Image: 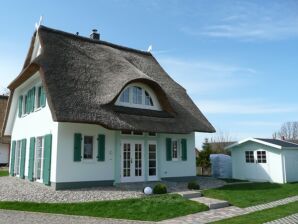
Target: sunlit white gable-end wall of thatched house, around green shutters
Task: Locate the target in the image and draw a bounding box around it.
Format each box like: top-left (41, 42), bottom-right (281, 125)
top-left (9, 72), bottom-right (58, 182)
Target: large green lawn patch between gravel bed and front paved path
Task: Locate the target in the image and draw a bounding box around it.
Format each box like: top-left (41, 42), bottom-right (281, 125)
top-left (0, 194), bottom-right (208, 221)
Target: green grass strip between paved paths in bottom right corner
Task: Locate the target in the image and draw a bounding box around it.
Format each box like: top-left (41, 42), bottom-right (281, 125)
top-left (213, 202), bottom-right (298, 224)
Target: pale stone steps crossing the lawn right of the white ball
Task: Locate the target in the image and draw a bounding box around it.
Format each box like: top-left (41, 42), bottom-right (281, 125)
top-left (178, 191), bottom-right (230, 209)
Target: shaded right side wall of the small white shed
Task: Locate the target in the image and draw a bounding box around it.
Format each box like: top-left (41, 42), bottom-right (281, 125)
top-left (283, 149), bottom-right (298, 182)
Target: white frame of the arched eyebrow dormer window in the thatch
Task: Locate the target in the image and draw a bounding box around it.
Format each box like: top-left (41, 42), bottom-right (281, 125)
top-left (115, 83), bottom-right (161, 111)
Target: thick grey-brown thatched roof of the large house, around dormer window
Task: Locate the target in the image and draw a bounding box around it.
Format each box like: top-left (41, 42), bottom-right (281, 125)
top-left (3, 26), bottom-right (215, 133)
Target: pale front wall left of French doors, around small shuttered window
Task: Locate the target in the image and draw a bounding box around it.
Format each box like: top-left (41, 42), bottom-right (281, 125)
top-left (55, 123), bottom-right (115, 182)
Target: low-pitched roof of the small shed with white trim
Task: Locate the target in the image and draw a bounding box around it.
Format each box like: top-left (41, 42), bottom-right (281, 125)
top-left (225, 138), bottom-right (298, 149)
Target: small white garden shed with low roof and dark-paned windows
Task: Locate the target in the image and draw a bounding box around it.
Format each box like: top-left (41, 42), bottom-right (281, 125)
top-left (225, 138), bottom-right (298, 183)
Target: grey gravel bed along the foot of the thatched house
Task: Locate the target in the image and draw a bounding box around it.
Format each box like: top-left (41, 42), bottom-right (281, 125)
top-left (0, 177), bottom-right (225, 203)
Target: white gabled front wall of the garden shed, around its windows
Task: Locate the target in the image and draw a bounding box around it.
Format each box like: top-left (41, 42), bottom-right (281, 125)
top-left (231, 141), bottom-right (284, 183)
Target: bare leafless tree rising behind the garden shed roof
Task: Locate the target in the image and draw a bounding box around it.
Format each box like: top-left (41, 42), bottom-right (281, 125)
top-left (277, 121), bottom-right (298, 140)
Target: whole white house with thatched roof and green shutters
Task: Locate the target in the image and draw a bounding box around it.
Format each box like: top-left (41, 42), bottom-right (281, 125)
top-left (3, 26), bottom-right (214, 189)
